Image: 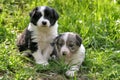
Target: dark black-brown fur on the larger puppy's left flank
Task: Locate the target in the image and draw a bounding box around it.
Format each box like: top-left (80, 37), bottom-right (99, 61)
top-left (17, 28), bottom-right (37, 52)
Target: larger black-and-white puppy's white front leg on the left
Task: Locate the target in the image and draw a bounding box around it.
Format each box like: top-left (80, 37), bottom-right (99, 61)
top-left (32, 49), bottom-right (48, 66)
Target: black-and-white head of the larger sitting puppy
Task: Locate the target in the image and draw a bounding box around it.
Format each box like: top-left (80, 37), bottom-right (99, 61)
top-left (30, 6), bottom-right (59, 27)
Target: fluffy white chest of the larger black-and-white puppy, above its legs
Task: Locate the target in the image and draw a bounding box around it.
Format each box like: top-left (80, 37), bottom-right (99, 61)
top-left (28, 23), bottom-right (58, 50)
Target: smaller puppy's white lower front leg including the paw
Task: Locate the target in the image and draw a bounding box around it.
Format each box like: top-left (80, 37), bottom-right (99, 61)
top-left (66, 65), bottom-right (79, 77)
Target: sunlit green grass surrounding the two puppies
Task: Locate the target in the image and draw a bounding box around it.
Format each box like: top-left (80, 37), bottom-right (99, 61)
top-left (0, 0), bottom-right (120, 80)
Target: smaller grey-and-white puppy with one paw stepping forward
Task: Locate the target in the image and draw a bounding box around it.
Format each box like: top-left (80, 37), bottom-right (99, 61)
top-left (54, 32), bottom-right (85, 77)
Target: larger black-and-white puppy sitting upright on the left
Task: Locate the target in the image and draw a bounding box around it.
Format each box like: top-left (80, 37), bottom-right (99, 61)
top-left (17, 6), bottom-right (59, 65)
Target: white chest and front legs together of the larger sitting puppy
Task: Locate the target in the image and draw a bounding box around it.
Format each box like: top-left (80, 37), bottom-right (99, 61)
top-left (28, 22), bottom-right (58, 65)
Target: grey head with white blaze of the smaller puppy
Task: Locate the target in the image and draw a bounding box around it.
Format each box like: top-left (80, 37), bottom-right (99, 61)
top-left (54, 32), bottom-right (82, 57)
